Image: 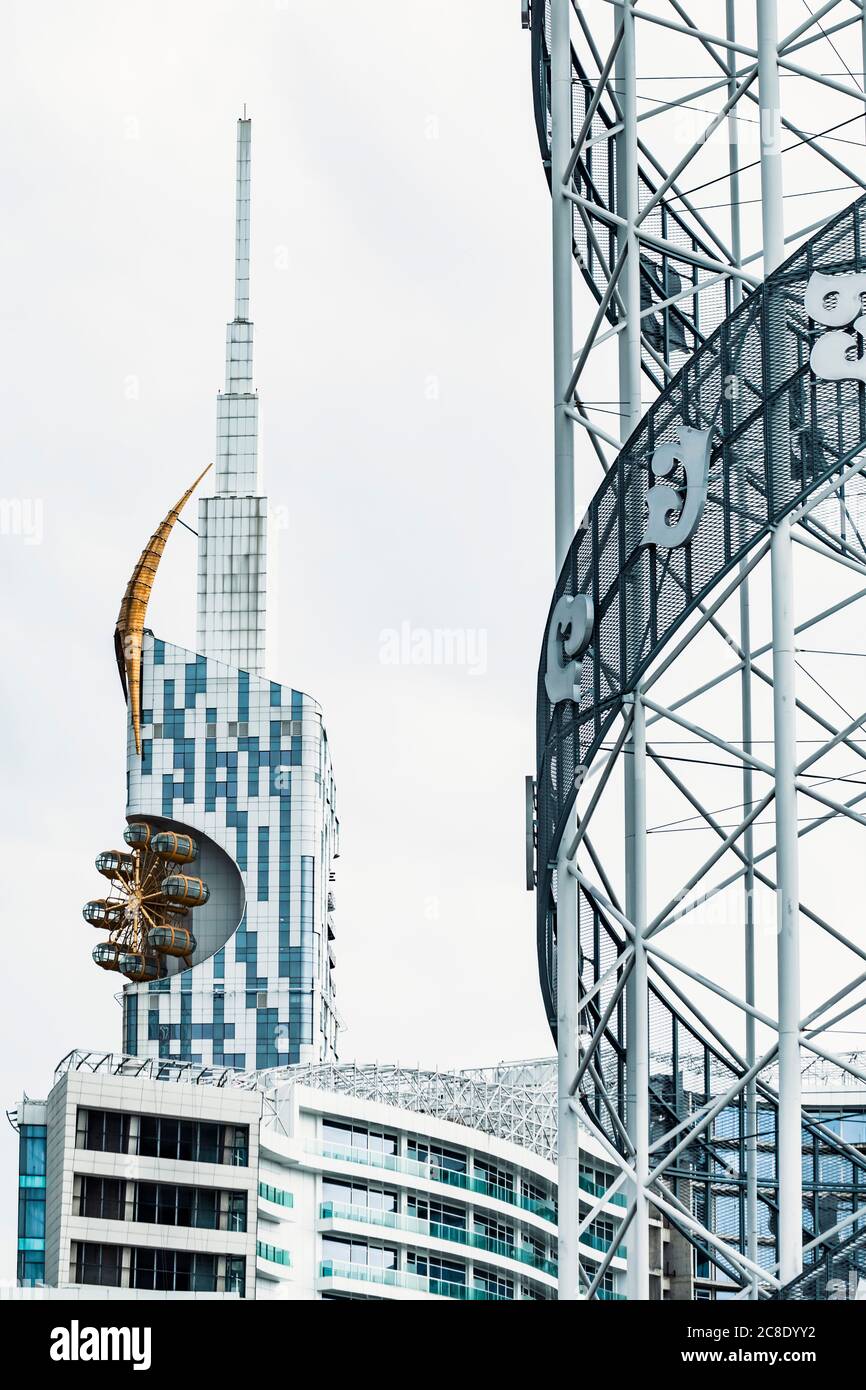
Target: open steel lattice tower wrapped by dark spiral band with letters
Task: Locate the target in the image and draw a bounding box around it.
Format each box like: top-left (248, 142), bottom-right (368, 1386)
top-left (524, 0), bottom-right (866, 1300)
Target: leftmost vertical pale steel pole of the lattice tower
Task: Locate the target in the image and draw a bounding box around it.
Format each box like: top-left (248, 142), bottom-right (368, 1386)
top-left (550, 0), bottom-right (580, 1300)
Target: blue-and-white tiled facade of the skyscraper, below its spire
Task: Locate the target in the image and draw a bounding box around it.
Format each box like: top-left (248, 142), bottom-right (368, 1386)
top-left (124, 635), bottom-right (339, 1069)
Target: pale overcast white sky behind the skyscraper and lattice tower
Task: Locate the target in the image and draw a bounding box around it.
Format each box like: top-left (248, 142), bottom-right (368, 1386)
top-left (0, 0), bottom-right (863, 1277)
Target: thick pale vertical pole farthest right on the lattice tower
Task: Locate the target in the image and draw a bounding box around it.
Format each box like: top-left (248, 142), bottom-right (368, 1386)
top-left (758, 0), bottom-right (803, 1282)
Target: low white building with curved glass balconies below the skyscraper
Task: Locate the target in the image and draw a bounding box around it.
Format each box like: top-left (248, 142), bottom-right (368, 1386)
top-left (11, 1052), bottom-right (626, 1301)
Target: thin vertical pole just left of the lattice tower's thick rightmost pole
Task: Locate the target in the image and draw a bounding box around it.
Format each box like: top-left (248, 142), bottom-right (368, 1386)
top-left (724, 0), bottom-right (758, 1300)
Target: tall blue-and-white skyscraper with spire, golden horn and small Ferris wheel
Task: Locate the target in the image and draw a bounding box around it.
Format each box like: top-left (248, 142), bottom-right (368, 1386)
top-left (100, 118), bottom-right (339, 1069)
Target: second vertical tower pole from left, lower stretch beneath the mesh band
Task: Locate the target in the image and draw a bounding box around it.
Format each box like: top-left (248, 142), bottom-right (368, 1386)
top-left (624, 691), bottom-right (649, 1301)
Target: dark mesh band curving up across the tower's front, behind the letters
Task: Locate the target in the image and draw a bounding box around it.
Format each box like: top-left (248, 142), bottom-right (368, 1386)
top-left (537, 199), bottom-right (866, 1016)
